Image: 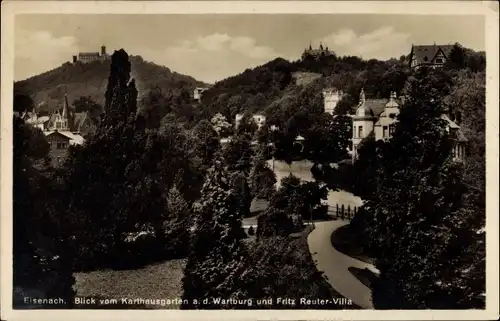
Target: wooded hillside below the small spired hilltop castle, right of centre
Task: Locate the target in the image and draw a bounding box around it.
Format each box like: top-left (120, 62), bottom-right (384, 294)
top-left (198, 44), bottom-right (485, 120)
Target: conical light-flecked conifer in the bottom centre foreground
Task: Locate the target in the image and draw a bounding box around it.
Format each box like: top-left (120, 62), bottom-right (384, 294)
top-left (182, 161), bottom-right (250, 309)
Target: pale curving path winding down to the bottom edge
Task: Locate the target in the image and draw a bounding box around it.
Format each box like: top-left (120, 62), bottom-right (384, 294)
top-left (307, 220), bottom-right (378, 309)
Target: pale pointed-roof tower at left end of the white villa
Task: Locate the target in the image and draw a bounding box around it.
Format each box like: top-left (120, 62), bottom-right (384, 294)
top-left (352, 89), bottom-right (376, 162)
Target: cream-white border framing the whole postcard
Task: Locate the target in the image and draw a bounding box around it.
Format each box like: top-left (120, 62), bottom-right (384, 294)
top-left (0, 1), bottom-right (499, 321)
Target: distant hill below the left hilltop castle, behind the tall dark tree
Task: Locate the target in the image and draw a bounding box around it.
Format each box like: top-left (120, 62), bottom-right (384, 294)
top-left (14, 56), bottom-right (207, 113)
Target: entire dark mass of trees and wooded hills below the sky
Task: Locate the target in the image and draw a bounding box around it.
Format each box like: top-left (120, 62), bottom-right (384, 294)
top-left (14, 40), bottom-right (485, 309)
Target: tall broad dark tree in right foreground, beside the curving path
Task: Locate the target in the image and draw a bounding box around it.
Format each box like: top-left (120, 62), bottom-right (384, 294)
top-left (363, 68), bottom-right (484, 309)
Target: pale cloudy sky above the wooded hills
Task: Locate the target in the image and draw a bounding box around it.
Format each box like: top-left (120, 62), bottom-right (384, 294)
top-left (14, 14), bottom-right (485, 83)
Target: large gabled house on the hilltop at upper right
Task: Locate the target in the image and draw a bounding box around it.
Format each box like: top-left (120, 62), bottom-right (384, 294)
top-left (409, 44), bottom-right (453, 69)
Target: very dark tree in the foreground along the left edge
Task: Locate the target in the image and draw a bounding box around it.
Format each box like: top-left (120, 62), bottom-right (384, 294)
top-left (13, 117), bottom-right (75, 308)
